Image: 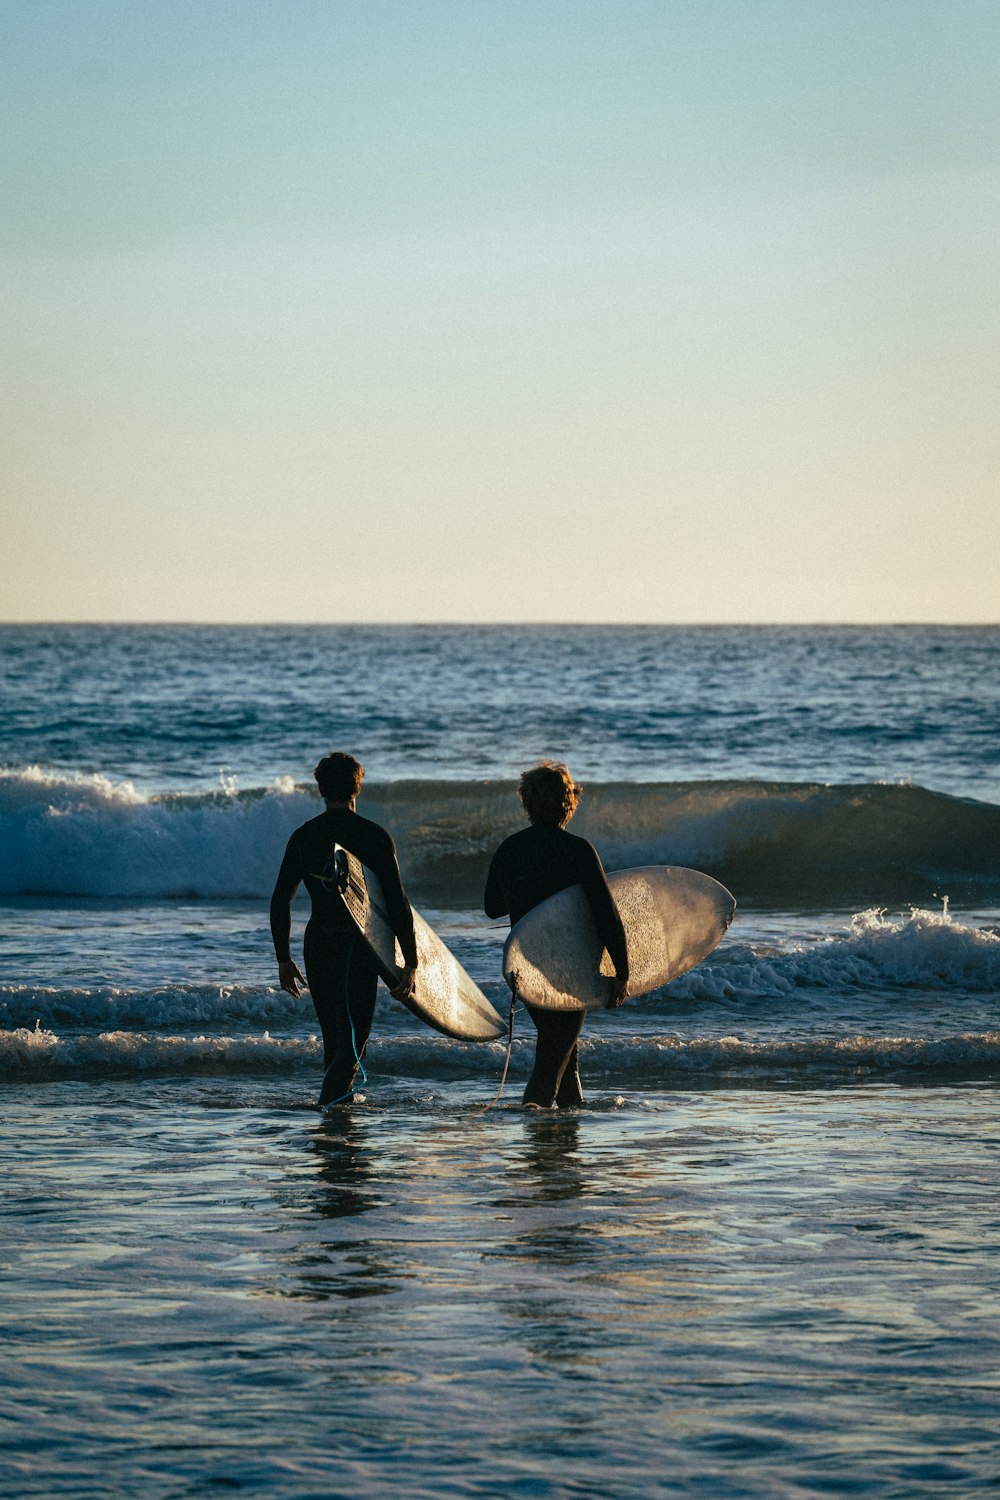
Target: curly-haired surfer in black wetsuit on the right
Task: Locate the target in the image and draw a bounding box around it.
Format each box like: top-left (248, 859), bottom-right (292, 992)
top-left (483, 761), bottom-right (628, 1109)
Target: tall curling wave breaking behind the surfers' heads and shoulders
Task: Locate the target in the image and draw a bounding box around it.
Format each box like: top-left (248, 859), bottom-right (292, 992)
top-left (0, 767), bottom-right (1000, 908)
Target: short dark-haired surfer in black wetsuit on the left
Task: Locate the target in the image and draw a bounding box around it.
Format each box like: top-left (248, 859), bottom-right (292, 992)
top-left (271, 752), bottom-right (417, 1104)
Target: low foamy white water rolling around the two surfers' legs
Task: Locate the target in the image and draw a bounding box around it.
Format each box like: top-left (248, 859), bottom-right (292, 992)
top-left (0, 911), bottom-right (1000, 1089)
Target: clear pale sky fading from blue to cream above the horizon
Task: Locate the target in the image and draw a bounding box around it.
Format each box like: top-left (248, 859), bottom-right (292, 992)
top-left (0, 0), bottom-right (1000, 623)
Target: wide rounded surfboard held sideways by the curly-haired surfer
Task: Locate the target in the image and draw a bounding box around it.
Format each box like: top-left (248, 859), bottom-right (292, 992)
top-left (504, 864), bottom-right (736, 1011)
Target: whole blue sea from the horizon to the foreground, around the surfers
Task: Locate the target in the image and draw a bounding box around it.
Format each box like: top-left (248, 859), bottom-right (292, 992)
top-left (0, 627), bottom-right (1000, 1500)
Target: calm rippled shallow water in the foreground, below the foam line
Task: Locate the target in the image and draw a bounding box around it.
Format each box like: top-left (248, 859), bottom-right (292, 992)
top-left (0, 1080), bottom-right (1000, 1497)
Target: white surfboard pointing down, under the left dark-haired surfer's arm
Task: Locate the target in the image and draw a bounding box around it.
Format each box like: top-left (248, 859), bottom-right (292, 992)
top-left (330, 846), bottom-right (507, 1041)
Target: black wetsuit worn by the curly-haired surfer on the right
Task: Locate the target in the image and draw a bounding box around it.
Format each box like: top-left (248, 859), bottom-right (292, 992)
top-left (483, 824), bottom-right (628, 1107)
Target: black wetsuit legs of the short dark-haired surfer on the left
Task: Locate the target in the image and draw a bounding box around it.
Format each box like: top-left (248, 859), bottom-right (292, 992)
top-left (303, 929), bottom-right (378, 1104)
